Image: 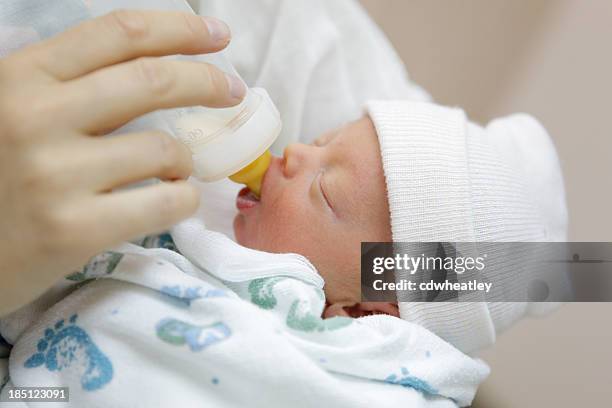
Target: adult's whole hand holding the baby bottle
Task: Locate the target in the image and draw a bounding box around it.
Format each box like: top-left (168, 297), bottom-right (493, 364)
top-left (0, 11), bottom-right (245, 316)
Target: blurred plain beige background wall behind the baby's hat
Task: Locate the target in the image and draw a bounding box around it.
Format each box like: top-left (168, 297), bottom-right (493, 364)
top-left (361, 0), bottom-right (612, 408)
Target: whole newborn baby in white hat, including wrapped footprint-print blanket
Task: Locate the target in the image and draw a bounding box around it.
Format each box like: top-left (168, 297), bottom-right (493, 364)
top-left (0, 101), bottom-right (565, 407)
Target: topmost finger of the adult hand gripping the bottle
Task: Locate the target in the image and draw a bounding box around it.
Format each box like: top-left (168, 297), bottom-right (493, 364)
top-left (24, 10), bottom-right (230, 80)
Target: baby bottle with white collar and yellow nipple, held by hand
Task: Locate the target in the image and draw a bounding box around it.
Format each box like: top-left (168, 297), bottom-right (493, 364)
top-left (86, 0), bottom-right (281, 196)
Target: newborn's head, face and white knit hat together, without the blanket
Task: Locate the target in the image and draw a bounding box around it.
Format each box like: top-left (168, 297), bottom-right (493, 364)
top-left (234, 101), bottom-right (566, 351)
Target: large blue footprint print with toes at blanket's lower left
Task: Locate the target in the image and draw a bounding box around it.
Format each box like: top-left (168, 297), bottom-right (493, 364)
top-left (24, 314), bottom-right (113, 391)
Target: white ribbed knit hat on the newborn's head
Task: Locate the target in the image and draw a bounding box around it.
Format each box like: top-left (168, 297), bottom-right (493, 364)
top-left (367, 101), bottom-right (567, 352)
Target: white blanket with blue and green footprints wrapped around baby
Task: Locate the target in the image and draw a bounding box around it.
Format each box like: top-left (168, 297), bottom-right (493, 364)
top-left (2, 228), bottom-right (488, 407)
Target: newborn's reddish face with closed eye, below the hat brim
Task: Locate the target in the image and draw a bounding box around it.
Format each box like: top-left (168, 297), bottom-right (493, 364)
top-left (234, 117), bottom-right (391, 303)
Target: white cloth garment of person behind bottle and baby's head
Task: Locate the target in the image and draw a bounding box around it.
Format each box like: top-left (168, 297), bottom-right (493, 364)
top-left (192, 0), bottom-right (430, 153)
